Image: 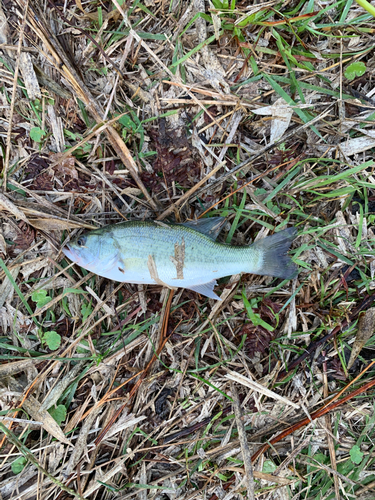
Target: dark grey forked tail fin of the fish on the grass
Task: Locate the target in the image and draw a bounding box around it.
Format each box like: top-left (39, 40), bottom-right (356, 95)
top-left (251, 227), bottom-right (298, 279)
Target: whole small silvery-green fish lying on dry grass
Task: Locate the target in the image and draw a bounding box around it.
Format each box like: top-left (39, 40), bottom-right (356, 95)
top-left (62, 217), bottom-right (298, 300)
